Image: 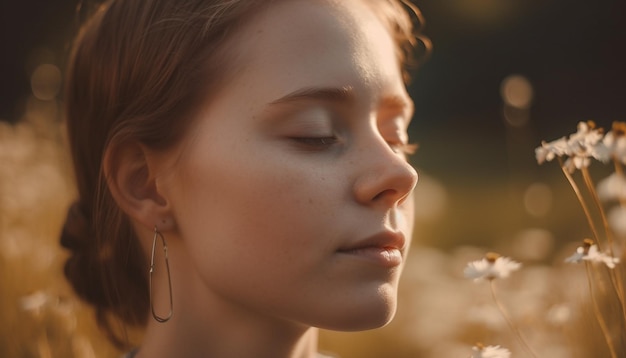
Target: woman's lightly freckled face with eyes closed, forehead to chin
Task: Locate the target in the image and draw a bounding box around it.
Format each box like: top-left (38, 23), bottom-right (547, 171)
top-left (160, 1), bottom-right (417, 330)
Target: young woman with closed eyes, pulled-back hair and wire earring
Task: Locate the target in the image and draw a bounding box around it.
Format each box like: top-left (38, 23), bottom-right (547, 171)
top-left (62, 0), bottom-right (426, 358)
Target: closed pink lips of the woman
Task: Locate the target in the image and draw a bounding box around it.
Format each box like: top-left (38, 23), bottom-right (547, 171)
top-left (338, 231), bottom-right (406, 267)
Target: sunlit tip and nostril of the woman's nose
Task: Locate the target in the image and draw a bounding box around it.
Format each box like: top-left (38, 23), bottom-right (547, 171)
top-left (354, 142), bottom-right (418, 208)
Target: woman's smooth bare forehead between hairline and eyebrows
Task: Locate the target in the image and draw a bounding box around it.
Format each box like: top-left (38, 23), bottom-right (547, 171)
top-left (222, 0), bottom-right (403, 95)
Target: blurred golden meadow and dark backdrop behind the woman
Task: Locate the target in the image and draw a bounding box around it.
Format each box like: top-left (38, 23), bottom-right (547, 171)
top-left (0, 0), bottom-right (626, 358)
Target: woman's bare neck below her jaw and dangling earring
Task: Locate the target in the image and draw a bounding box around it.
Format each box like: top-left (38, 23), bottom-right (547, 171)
top-left (136, 242), bottom-right (318, 358)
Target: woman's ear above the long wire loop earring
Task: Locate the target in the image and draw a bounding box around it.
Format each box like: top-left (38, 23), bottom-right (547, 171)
top-left (103, 142), bottom-right (174, 231)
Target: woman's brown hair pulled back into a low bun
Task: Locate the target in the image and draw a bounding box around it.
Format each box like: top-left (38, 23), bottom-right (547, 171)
top-left (61, 0), bottom-right (429, 348)
